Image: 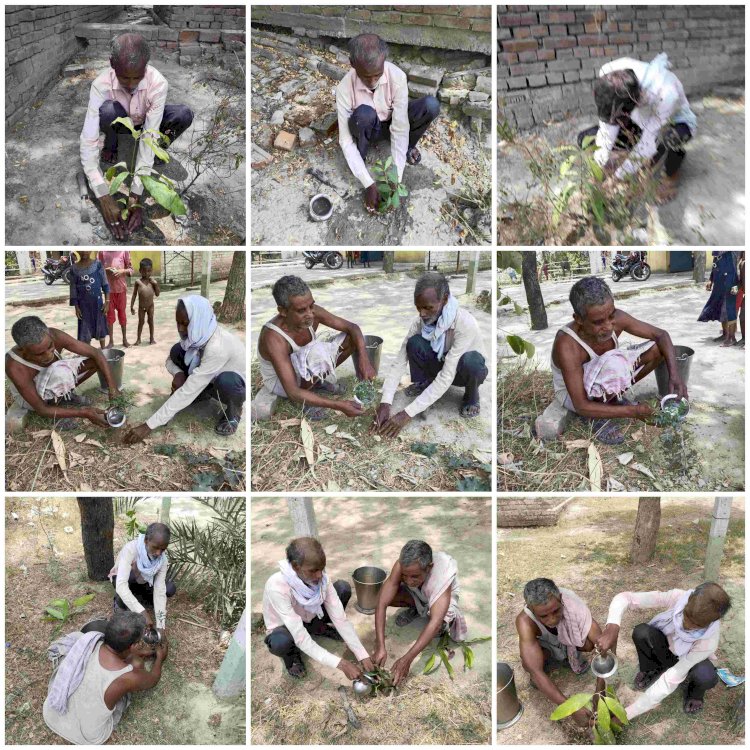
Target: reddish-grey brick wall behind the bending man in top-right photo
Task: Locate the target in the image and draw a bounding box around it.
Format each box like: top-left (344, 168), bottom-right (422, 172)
top-left (497, 5), bottom-right (745, 130)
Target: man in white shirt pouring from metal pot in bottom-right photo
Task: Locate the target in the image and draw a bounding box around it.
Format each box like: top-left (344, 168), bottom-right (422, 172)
top-left (596, 581), bottom-right (732, 720)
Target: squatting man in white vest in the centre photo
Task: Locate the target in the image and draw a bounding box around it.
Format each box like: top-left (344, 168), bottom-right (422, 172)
top-left (258, 276), bottom-right (375, 421)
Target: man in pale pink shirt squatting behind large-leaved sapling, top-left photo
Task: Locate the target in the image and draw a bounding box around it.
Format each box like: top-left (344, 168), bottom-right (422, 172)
top-left (80, 33), bottom-right (193, 240)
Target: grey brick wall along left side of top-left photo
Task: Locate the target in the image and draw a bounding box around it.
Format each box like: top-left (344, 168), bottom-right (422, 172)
top-left (5, 5), bottom-right (124, 125)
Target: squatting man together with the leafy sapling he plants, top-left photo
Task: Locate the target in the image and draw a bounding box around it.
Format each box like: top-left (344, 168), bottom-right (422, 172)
top-left (80, 32), bottom-right (193, 240)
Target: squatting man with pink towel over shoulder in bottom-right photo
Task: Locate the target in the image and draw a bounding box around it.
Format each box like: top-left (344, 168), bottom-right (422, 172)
top-left (516, 578), bottom-right (605, 727)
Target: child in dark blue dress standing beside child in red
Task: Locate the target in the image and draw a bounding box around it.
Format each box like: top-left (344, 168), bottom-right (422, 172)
top-left (70, 250), bottom-right (109, 349)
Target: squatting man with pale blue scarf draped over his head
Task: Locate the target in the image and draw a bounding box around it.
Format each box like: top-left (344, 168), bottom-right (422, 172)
top-left (124, 294), bottom-right (246, 445)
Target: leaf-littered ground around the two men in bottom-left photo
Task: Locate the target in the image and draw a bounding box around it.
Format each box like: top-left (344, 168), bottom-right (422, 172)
top-left (5, 497), bottom-right (245, 745)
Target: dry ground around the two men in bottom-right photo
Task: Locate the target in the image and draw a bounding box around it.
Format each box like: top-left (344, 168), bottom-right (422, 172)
top-left (497, 496), bottom-right (745, 746)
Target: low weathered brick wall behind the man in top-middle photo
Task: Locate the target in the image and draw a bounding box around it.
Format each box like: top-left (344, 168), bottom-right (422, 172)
top-left (250, 5), bottom-right (492, 55)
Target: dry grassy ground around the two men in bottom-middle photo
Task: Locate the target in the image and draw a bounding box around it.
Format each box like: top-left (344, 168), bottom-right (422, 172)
top-left (251, 497), bottom-right (493, 745)
